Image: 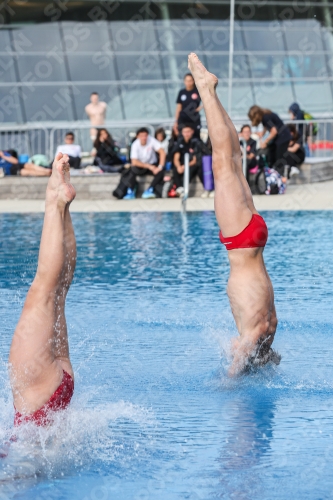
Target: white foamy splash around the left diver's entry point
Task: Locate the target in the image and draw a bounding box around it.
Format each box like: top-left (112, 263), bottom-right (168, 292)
top-left (0, 393), bottom-right (154, 490)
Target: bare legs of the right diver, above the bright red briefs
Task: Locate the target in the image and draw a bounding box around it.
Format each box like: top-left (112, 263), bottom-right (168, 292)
top-left (189, 53), bottom-right (257, 236)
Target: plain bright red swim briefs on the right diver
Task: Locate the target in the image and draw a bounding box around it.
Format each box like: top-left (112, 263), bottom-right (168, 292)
top-left (220, 214), bottom-right (268, 250)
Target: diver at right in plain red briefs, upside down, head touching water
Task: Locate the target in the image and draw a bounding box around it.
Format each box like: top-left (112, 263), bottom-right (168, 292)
top-left (189, 53), bottom-right (280, 376)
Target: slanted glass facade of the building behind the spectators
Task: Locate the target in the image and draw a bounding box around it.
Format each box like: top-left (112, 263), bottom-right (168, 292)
top-left (0, 0), bottom-right (333, 123)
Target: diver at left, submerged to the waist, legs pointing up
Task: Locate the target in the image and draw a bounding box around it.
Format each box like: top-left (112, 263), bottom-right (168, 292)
top-left (9, 153), bottom-right (76, 425)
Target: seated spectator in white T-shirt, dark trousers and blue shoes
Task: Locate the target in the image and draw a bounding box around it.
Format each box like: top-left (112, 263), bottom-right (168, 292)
top-left (124, 127), bottom-right (166, 200)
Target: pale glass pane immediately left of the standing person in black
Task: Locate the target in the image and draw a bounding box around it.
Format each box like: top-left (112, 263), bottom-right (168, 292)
top-left (121, 84), bottom-right (168, 120)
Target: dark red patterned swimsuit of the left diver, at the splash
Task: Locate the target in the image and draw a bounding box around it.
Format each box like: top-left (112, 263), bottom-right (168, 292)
top-left (14, 370), bottom-right (74, 427)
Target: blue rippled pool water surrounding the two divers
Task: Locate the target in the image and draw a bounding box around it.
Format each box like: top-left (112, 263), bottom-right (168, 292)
top-left (0, 212), bottom-right (333, 500)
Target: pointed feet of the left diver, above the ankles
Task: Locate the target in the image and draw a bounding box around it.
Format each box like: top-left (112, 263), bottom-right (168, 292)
top-left (47, 153), bottom-right (76, 208)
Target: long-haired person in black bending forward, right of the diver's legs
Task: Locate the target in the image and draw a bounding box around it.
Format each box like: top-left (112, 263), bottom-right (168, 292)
top-left (248, 106), bottom-right (291, 176)
